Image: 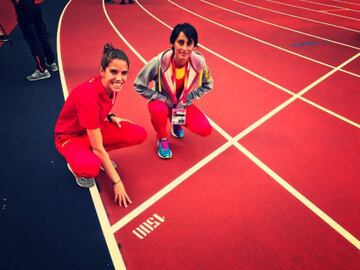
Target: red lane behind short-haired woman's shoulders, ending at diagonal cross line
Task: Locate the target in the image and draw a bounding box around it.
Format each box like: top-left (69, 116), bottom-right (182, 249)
top-left (107, 2), bottom-right (290, 136)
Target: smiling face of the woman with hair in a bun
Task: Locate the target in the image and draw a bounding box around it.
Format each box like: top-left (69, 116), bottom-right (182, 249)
top-left (100, 58), bottom-right (129, 96)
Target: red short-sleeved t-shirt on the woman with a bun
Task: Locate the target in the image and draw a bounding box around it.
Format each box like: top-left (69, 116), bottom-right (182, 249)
top-left (55, 76), bottom-right (115, 135)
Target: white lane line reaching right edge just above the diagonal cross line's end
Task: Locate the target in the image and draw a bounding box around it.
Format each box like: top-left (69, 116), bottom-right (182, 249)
top-left (200, 0), bottom-right (360, 50)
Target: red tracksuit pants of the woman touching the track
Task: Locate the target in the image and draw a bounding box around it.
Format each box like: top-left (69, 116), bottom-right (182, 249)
top-left (55, 122), bottom-right (147, 178)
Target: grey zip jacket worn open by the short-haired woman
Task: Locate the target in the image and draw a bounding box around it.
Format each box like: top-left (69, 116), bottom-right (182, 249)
top-left (134, 49), bottom-right (213, 108)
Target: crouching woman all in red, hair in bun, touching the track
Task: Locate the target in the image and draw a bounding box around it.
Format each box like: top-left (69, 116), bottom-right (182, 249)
top-left (55, 44), bottom-right (146, 207)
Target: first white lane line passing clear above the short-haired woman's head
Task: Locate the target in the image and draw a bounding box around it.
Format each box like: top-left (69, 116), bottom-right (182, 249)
top-left (168, 0), bottom-right (360, 78)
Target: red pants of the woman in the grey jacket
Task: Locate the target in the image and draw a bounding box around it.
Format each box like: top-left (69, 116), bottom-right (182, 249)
top-left (148, 100), bottom-right (212, 139)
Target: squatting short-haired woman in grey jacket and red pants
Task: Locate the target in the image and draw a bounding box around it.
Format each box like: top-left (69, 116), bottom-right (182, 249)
top-left (134, 23), bottom-right (213, 159)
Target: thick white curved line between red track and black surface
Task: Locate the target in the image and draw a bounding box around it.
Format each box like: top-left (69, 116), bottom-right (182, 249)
top-left (57, 0), bottom-right (126, 270)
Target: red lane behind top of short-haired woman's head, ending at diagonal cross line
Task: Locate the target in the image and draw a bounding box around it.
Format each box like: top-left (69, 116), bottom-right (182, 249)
top-left (138, 1), bottom-right (329, 92)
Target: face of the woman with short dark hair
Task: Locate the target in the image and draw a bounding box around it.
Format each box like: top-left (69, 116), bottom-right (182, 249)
top-left (172, 32), bottom-right (195, 67)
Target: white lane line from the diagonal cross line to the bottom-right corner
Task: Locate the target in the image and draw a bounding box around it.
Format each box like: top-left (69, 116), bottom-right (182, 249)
top-left (234, 143), bottom-right (360, 250)
